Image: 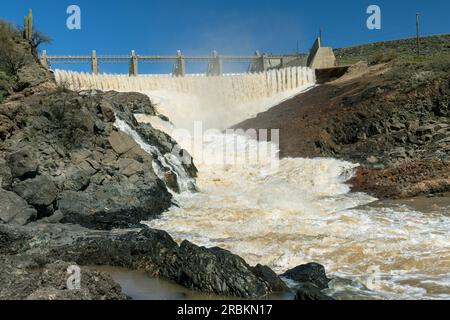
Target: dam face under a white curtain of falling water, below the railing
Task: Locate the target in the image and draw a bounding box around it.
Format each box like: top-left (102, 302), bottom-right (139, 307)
top-left (55, 67), bottom-right (316, 130)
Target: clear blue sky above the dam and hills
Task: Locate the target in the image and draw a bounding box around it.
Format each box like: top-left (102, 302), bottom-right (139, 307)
top-left (0, 0), bottom-right (450, 72)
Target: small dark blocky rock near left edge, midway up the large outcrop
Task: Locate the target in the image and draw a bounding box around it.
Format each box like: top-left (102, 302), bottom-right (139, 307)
top-left (6, 146), bottom-right (38, 178)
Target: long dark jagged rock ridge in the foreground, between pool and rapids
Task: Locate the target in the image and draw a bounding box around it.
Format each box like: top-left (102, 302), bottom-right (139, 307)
top-left (0, 224), bottom-right (281, 298)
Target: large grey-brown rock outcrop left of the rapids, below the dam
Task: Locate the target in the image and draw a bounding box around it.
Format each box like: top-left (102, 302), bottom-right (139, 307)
top-left (0, 82), bottom-right (196, 229)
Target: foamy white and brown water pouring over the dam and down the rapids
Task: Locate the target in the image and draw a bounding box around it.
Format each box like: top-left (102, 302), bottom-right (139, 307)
top-left (56, 69), bottom-right (450, 299)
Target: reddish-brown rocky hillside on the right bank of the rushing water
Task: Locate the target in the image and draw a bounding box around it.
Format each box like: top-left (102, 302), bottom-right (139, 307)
top-left (236, 42), bottom-right (450, 197)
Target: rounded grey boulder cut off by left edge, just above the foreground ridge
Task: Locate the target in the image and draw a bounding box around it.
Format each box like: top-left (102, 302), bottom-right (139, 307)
top-left (0, 188), bottom-right (37, 225)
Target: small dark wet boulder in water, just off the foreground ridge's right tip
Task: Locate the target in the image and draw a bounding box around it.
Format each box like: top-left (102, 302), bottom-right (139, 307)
top-left (281, 263), bottom-right (331, 290)
